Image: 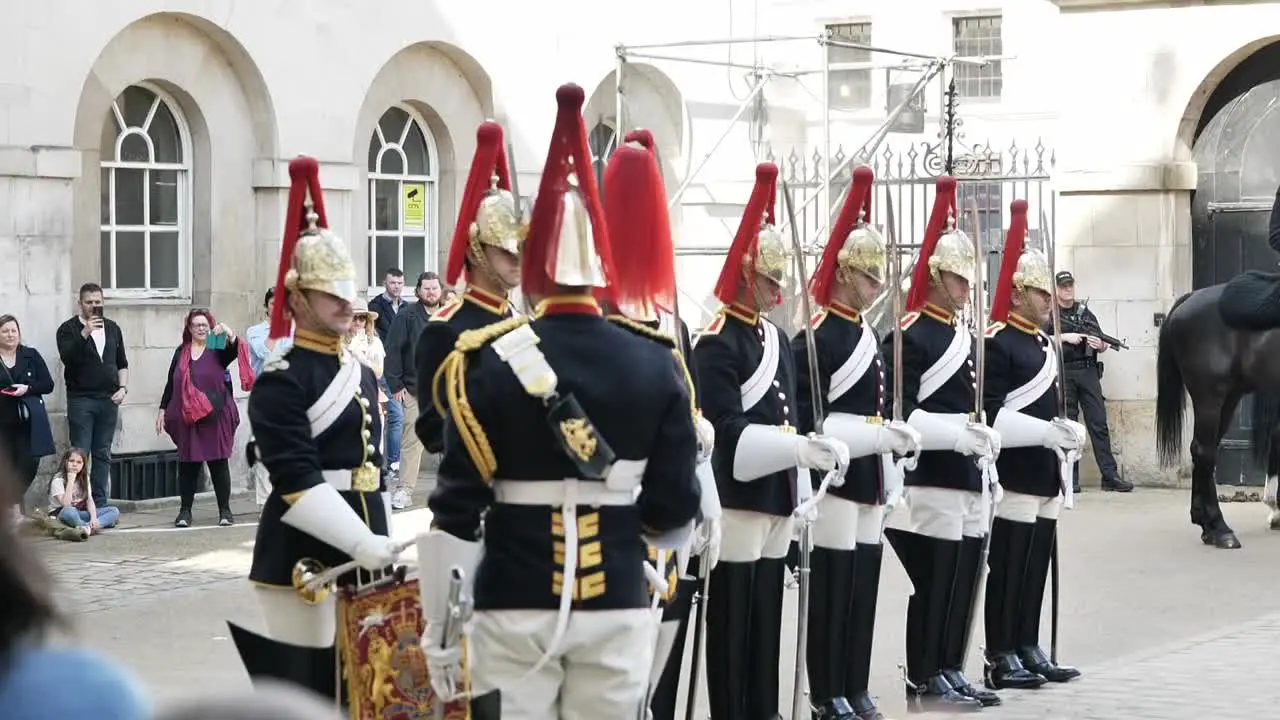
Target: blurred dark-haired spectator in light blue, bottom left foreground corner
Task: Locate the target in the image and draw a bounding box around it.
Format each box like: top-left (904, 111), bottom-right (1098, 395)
top-left (0, 459), bottom-right (151, 720)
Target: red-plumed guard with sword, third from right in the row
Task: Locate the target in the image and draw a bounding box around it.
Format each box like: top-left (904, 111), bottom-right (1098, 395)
top-left (791, 167), bottom-right (919, 720)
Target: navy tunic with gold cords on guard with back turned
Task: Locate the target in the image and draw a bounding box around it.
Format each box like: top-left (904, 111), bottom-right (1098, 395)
top-left (429, 299), bottom-right (701, 610)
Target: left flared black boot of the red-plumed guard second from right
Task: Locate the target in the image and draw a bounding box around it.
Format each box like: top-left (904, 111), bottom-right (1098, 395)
top-left (884, 529), bottom-right (982, 712)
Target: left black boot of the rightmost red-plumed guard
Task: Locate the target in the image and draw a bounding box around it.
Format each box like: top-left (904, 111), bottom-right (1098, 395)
top-left (983, 518), bottom-right (1044, 691)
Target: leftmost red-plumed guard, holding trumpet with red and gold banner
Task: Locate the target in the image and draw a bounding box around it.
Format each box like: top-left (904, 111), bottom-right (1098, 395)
top-left (230, 158), bottom-right (397, 697)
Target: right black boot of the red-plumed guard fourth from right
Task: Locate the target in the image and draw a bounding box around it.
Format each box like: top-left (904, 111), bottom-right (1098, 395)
top-left (737, 557), bottom-right (783, 720)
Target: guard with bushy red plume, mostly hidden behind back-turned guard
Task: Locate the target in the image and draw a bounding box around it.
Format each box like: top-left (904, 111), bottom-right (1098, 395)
top-left (604, 129), bottom-right (721, 720)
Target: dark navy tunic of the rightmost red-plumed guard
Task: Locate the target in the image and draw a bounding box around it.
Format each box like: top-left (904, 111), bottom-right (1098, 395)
top-left (983, 314), bottom-right (1061, 497)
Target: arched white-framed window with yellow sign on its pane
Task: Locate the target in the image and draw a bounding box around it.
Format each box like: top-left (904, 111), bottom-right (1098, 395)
top-left (369, 106), bottom-right (438, 287)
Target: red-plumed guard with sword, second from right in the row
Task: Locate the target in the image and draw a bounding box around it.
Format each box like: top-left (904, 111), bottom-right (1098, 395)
top-left (884, 177), bottom-right (1000, 712)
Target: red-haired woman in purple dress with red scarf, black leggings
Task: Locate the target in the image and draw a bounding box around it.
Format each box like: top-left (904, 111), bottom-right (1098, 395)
top-left (156, 310), bottom-right (253, 528)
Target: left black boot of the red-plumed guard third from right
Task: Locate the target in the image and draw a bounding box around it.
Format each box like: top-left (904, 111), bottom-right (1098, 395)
top-left (801, 547), bottom-right (856, 720)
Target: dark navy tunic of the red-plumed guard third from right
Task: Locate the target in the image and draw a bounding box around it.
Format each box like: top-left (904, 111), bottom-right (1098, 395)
top-left (791, 304), bottom-right (892, 505)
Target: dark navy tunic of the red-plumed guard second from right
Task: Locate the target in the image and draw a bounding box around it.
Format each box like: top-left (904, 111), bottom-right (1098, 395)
top-left (883, 299), bottom-right (982, 492)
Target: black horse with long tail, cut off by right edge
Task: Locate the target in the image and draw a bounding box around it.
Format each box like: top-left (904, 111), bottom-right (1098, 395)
top-left (1156, 281), bottom-right (1280, 550)
